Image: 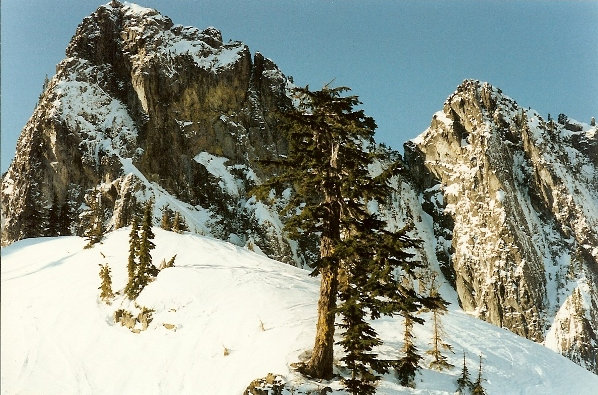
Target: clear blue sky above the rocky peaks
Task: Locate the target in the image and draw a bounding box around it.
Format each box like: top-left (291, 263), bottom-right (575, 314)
top-left (1, 0), bottom-right (598, 172)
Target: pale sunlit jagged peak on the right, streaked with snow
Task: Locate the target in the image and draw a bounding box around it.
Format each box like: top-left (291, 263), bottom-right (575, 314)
top-left (405, 81), bottom-right (598, 372)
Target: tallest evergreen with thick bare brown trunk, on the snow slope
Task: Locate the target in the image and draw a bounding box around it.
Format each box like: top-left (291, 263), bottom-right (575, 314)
top-left (259, 86), bottom-right (392, 379)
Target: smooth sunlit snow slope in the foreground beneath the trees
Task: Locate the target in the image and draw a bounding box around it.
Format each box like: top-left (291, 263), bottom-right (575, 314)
top-left (0, 228), bottom-right (598, 395)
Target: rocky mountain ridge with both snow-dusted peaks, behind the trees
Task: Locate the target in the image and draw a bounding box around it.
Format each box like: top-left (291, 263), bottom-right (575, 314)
top-left (1, 1), bottom-right (598, 373)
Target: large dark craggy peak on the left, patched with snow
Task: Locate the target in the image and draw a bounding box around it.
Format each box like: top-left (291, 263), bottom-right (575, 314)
top-left (2, 2), bottom-right (297, 260)
